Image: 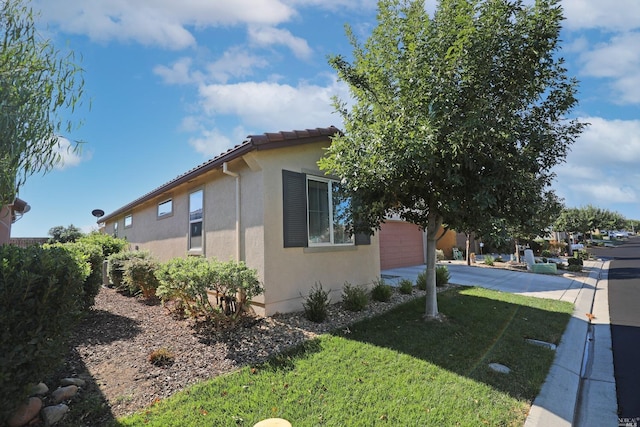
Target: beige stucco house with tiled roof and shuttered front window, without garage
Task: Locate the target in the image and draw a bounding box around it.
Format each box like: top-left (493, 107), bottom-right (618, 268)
top-left (98, 127), bottom-right (380, 315)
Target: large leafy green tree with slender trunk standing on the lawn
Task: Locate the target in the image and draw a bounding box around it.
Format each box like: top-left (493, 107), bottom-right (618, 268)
top-left (320, 0), bottom-right (583, 319)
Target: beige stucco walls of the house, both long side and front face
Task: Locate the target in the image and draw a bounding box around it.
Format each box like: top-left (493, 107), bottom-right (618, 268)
top-left (105, 143), bottom-right (380, 315)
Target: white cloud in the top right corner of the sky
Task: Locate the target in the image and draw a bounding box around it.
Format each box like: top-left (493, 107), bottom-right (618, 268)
top-left (562, 0), bottom-right (640, 31)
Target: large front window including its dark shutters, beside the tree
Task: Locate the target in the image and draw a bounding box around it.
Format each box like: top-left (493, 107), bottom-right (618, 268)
top-left (282, 170), bottom-right (371, 248)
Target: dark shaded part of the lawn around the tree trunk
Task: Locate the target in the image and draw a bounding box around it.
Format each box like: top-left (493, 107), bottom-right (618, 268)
top-left (335, 288), bottom-right (572, 400)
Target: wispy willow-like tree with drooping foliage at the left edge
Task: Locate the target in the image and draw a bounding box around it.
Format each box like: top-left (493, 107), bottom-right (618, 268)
top-left (0, 0), bottom-right (84, 206)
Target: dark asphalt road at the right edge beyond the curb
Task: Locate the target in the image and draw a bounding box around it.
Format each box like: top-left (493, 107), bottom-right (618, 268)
top-left (590, 237), bottom-right (640, 427)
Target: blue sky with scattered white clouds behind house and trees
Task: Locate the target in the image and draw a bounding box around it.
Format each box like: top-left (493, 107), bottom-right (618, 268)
top-left (12, 0), bottom-right (640, 237)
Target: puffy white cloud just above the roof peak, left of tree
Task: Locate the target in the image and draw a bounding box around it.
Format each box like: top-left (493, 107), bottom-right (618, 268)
top-left (199, 77), bottom-right (345, 131)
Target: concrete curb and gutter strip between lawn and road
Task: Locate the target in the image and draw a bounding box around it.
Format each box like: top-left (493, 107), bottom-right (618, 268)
top-left (525, 262), bottom-right (618, 427)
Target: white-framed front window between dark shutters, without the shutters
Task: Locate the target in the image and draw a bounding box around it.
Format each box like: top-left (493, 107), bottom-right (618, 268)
top-left (307, 176), bottom-right (353, 246)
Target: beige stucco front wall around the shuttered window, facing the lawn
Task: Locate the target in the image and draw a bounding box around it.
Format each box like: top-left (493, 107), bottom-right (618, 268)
top-left (259, 143), bottom-right (380, 315)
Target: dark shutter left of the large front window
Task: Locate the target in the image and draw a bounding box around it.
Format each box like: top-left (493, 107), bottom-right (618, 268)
top-left (282, 170), bottom-right (309, 248)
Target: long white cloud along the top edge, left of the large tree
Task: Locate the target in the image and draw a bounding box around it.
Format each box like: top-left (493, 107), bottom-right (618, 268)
top-left (34, 0), bottom-right (295, 49)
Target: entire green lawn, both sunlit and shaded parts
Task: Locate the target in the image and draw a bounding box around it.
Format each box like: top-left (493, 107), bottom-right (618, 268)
top-left (119, 288), bottom-right (573, 426)
